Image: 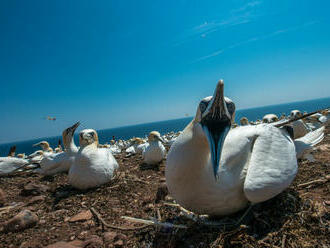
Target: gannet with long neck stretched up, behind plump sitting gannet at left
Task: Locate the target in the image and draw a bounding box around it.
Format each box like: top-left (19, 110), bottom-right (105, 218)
top-left (38, 122), bottom-right (80, 176)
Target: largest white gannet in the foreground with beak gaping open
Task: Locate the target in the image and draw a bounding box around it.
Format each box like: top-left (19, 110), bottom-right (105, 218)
top-left (165, 80), bottom-right (297, 216)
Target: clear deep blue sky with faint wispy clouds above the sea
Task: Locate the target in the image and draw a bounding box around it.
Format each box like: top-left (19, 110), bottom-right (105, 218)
top-left (0, 0), bottom-right (330, 143)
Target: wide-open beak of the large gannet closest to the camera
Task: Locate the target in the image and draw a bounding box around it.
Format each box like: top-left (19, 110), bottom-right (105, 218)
top-left (201, 80), bottom-right (232, 177)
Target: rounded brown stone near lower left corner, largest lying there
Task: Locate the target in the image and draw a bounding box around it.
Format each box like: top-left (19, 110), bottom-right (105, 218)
top-left (4, 210), bottom-right (39, 232)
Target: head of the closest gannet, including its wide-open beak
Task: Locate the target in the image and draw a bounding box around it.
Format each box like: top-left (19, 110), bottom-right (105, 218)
top-left (193, 80), bottom-right (235, 176)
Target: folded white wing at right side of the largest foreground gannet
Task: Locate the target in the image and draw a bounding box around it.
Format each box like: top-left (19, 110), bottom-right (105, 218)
top-left (244, 126), bottom-right (298, 203)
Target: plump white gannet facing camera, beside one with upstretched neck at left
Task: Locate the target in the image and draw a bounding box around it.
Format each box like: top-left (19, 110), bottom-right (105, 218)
top-left (69, 129), bottom-right (118, 190)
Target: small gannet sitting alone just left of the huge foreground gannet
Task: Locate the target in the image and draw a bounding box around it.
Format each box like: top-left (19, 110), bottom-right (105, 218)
top-left (142, 131), bottom-right (166, 165)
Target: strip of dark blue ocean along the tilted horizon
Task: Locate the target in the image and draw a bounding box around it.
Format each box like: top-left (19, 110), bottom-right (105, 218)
top-left (0, 97), bottom-right (330, 157)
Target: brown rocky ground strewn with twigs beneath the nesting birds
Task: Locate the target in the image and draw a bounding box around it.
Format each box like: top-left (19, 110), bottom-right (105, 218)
top-left (0, 126), bottom-right (330, 248)
